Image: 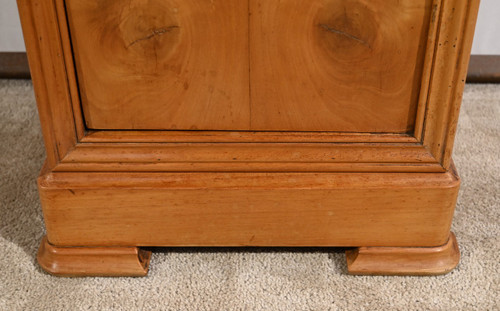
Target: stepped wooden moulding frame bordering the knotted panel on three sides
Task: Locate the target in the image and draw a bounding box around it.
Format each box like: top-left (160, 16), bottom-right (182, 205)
top-left (12, 0), bottom-right (478, 176)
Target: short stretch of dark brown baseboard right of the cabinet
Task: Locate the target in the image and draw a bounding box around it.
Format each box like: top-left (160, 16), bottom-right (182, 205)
top-left (467, 55), bottom-right (500, 83)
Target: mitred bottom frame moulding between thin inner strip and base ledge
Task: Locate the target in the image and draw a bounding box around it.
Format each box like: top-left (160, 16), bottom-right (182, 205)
top-left (54, 143), bottom-right (444, 172)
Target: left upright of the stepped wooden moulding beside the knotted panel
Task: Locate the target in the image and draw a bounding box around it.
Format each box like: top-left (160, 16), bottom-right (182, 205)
top-left (17, 0), bottom-right (81, 167)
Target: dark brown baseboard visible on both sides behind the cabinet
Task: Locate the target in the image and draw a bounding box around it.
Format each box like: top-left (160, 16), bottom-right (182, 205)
top-left (0, 52), bottom-right (500, 83)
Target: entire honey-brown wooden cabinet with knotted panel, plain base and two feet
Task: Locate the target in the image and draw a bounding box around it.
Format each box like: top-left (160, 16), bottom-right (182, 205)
top-left (18, 0), bottom-right (479, 275)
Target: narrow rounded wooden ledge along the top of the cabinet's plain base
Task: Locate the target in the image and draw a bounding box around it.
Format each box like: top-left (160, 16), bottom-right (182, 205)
top-left (38, 171), bottom-right (460, 191)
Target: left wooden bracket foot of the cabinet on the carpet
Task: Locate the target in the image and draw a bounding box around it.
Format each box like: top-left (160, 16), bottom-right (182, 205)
top-left (37, 237), bottom-right (151, 276)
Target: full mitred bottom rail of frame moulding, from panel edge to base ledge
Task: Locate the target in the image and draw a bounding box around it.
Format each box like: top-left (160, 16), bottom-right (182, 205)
top-left (66, 131), bottom-right (445, 172)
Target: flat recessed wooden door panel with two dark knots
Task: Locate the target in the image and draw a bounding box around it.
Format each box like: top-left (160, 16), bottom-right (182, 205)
top-left (66, 0), bottom-right (432, 133)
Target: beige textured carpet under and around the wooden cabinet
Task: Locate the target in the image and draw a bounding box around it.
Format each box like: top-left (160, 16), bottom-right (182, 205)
top-left (0, 80), bottom-right (500, 311)
